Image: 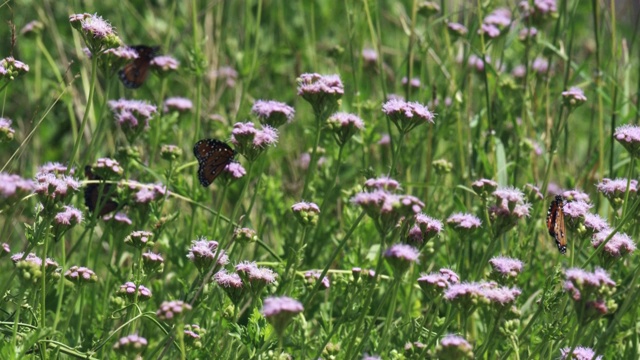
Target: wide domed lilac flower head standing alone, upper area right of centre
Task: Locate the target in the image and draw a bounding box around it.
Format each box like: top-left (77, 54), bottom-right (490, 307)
top-left (382, 99), bottom-right (435, 134)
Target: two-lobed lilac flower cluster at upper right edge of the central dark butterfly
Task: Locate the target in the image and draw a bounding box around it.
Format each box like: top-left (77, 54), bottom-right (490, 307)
top-left (231, 122), bottom-right (278, 161)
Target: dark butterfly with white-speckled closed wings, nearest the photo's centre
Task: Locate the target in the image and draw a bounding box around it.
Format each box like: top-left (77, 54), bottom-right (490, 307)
top-left (193, 139), bottom-right (236, 187)
